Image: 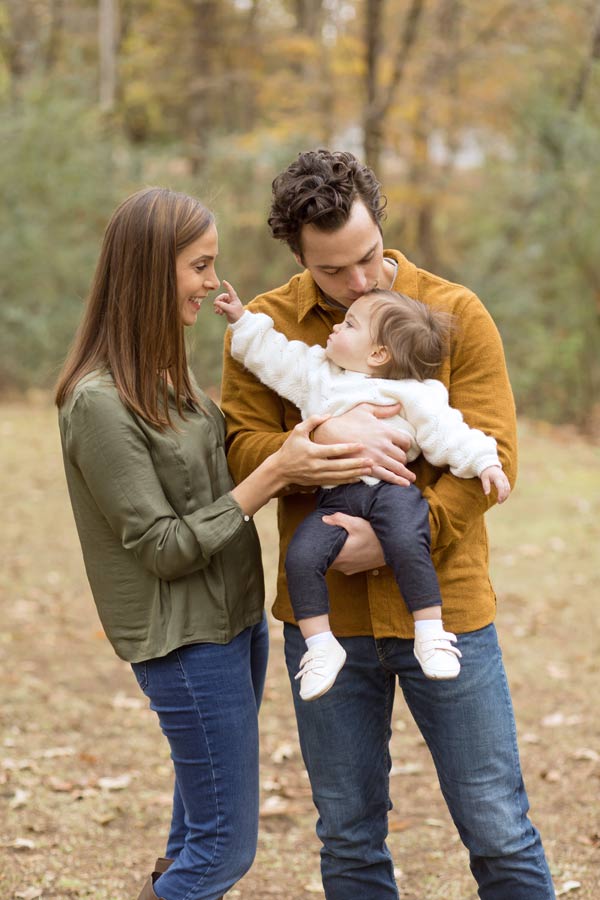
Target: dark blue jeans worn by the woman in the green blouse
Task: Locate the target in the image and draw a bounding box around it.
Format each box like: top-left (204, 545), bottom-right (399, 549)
top-left (132, 618), bottom-right (269, 900)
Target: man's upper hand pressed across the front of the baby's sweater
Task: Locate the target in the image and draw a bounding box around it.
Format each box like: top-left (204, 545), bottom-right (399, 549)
top-left (313, 403), bottom-right (415, 486)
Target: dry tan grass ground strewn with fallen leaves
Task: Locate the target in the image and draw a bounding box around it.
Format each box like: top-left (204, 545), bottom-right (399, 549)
top-left (0, 401), bottom-right (600, 900)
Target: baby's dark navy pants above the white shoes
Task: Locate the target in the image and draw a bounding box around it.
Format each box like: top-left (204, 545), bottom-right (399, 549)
top-left (285, 481), bottom-right (442, 622)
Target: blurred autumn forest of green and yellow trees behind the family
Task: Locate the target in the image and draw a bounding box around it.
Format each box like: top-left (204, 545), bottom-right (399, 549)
top-left (0, 0), bottom-right (600, 431)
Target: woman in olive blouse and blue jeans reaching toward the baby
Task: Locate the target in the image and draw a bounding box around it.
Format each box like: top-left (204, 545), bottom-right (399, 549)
top-left (56, 188), bottom-right (371, 900)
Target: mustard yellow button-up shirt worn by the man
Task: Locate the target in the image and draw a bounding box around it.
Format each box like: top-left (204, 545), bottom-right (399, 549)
top-left (221, 250), bottom-right (517, 638)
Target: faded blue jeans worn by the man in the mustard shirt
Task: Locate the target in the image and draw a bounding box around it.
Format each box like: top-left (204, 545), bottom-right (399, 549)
top-left (284, 624), bottom-right (554, 900)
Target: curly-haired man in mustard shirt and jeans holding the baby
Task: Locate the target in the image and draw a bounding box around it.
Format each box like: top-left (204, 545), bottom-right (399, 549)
top-left (222, 150), bottom-right (554, 900)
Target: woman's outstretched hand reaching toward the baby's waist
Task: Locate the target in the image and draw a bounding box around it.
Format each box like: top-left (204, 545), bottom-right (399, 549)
top-left (273, 416), bottom-right (373, 485)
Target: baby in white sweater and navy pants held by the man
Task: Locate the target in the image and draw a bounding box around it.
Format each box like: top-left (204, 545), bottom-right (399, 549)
top-left (214, 281), bottom-right (510, 700)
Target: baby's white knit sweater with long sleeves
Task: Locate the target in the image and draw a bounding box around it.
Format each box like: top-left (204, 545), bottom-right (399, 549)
top-left (230, 310), bottom-right (501, 484)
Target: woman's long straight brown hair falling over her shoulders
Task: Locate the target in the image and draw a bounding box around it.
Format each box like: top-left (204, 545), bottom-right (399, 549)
top-left (55, 188), bottom-right (214, 431)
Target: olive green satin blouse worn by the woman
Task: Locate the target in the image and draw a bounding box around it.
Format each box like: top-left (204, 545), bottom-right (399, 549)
top-left (59, 372), bottom-right (264, 662)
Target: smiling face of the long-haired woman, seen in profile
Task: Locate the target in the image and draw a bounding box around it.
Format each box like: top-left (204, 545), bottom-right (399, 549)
top-left (176, 224), bottom-right (220, 325)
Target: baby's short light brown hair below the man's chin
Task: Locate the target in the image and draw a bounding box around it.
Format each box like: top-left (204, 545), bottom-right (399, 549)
top-left (367, 289), bottom-right (454, 381)
